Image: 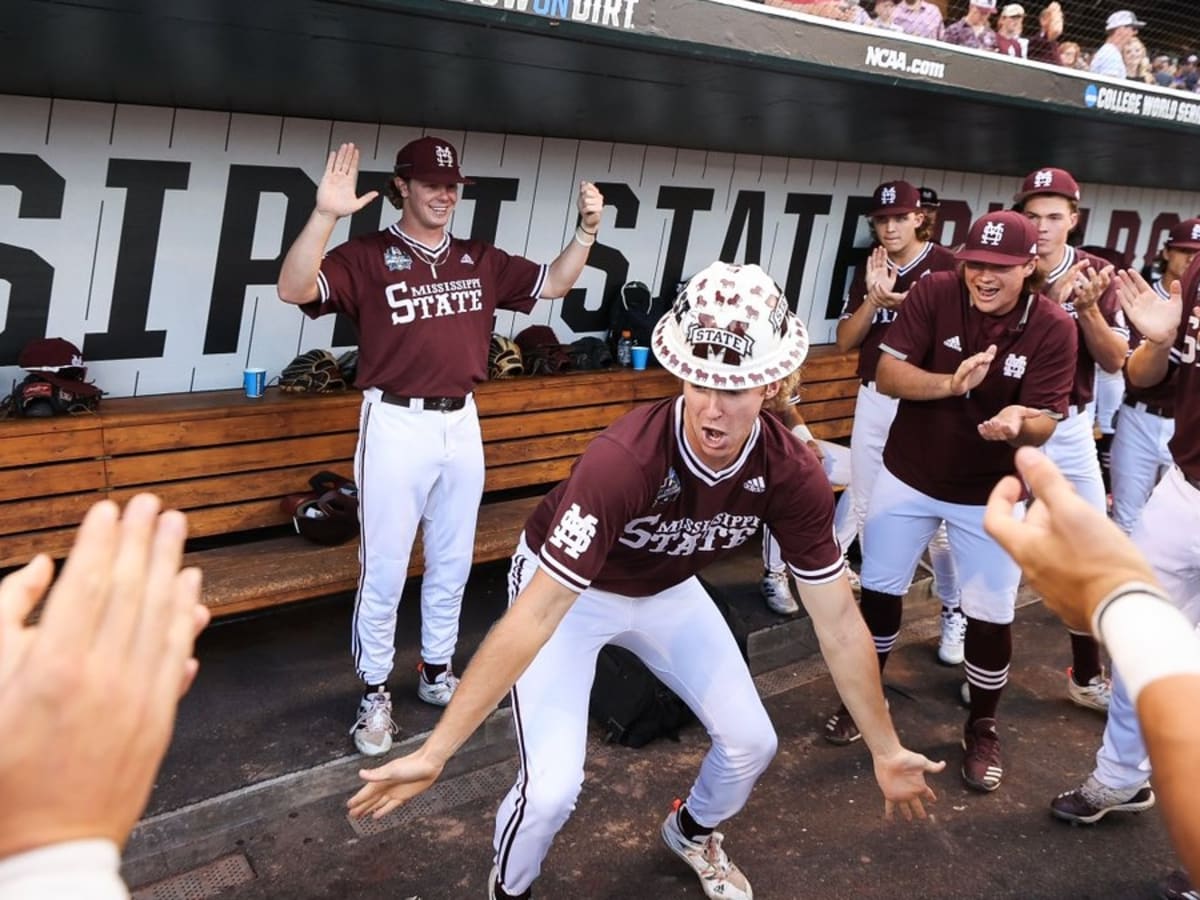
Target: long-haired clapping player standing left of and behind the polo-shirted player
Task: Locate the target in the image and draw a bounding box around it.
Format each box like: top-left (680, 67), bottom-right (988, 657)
top-left (826, 181), bottom-right (966, 672)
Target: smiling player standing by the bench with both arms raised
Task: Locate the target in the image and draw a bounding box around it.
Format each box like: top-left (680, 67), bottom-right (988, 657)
top-left (278, 137), bottom-right (604, 756)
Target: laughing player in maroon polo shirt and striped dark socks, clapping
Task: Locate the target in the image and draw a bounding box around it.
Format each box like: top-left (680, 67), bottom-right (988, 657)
top-left (827, 211), bottom-right (1076, 791)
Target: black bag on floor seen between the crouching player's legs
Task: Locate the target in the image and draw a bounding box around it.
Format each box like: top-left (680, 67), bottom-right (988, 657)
top-left (588, 581), bottom-right (748, 748)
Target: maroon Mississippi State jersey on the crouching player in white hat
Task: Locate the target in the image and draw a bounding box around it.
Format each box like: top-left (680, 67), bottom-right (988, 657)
top-left (524, 397), bottom-right (844, 596)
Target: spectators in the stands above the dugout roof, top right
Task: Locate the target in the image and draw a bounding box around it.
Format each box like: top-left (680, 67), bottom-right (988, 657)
top-left (764, 0), bottom-right (1200, 92)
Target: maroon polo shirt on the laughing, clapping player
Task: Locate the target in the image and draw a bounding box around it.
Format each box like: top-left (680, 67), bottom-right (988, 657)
top-left (882, 272), bottom-right (1076, 505)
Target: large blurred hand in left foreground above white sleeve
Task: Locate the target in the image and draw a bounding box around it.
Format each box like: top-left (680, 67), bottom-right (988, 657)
top-left (0, 494), bottom-right (208, 858)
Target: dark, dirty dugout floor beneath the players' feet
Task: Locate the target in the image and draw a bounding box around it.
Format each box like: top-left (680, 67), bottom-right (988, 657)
top-left (126, 552), bottom-right (1177, 900)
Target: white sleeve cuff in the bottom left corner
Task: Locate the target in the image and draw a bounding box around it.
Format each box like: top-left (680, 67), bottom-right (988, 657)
top-left (0, 839), bottom-right (130, 900)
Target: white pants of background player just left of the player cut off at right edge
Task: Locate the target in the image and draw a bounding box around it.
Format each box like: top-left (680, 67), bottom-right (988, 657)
top-left (1112, 403), bottom-right (1175, 534)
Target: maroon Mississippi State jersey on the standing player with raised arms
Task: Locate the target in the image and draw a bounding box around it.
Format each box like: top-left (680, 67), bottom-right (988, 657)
top-left (302, 223), bottom-right (546, 397)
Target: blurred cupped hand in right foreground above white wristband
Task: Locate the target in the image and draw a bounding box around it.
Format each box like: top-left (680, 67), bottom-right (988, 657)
top-left (984, 446), bottom-right (1154, 631)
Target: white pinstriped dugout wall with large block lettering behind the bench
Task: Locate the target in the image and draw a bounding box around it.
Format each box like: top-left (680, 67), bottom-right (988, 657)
top-left (0, 96), bottom-right (1200, 396)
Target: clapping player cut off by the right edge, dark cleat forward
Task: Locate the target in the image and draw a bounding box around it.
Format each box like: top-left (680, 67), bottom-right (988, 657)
top-left (1050, 259), bottom-right (1200, 824)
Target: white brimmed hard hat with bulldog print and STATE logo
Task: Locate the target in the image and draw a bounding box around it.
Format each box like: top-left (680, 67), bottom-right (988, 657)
top-left (652, 263), bottom-right (809, 388)
